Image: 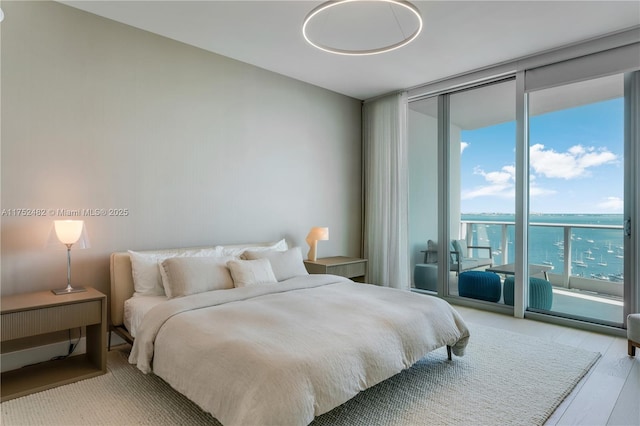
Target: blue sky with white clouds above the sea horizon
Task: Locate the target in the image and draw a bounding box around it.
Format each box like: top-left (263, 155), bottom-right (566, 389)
top-left (461, 98), bottom-right (624, 213)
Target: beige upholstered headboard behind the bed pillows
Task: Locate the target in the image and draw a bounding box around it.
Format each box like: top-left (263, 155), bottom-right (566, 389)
top-left (110, 239), bottom-right (287, 326)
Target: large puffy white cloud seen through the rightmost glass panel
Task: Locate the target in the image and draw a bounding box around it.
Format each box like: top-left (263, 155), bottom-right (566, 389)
top-left (529, 144), bottom-right (618, 179)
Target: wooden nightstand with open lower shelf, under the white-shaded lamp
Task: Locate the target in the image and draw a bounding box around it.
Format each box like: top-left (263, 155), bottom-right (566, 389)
top-left (0, 288), bottom-right (107, 401)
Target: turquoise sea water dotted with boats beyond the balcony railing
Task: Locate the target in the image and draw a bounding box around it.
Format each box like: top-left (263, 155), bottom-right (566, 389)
top-left (462, 213), bottom-right (624, 281)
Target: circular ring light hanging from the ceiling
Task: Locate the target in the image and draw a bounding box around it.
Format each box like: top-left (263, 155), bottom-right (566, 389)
top-left (302, 0), bottom-right (422, 56)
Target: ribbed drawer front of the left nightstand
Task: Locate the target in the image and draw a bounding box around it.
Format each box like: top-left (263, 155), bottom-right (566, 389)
top-left (1, 300), bottom-right (102, 341)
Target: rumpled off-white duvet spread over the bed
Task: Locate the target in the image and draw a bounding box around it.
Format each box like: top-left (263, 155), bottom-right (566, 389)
top-left (129, 275), bottom-right (469, 426)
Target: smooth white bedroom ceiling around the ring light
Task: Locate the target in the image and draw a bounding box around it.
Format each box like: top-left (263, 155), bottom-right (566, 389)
top-left (60, 0), bottom-right (640, 99)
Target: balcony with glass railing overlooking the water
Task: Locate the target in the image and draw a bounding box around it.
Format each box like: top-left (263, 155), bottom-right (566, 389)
top-left (452, 216), bottom-right (624, 324)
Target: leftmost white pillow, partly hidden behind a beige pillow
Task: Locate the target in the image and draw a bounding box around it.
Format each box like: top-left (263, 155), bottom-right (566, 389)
top-left (129, 247), bottom-right (222, 296)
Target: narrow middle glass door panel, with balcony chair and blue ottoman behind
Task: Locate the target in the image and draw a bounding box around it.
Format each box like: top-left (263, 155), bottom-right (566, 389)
top-left (448, 79), bottom-right (516, 305)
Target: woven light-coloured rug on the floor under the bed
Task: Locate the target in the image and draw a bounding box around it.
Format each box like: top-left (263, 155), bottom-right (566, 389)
top-left (1, 324), bottom-right (600, 426)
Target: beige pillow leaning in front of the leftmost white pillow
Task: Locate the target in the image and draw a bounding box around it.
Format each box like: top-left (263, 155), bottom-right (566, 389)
top-left (160, 256), bottom-right (233, 298)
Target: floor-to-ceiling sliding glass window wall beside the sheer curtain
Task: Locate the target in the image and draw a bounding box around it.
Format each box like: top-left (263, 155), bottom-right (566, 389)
top-left (409, 34), bottom-right (640, 327)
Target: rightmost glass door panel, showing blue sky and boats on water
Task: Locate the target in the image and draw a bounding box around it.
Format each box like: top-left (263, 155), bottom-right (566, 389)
top-left (528, 74), bottom-right (625, 326)
